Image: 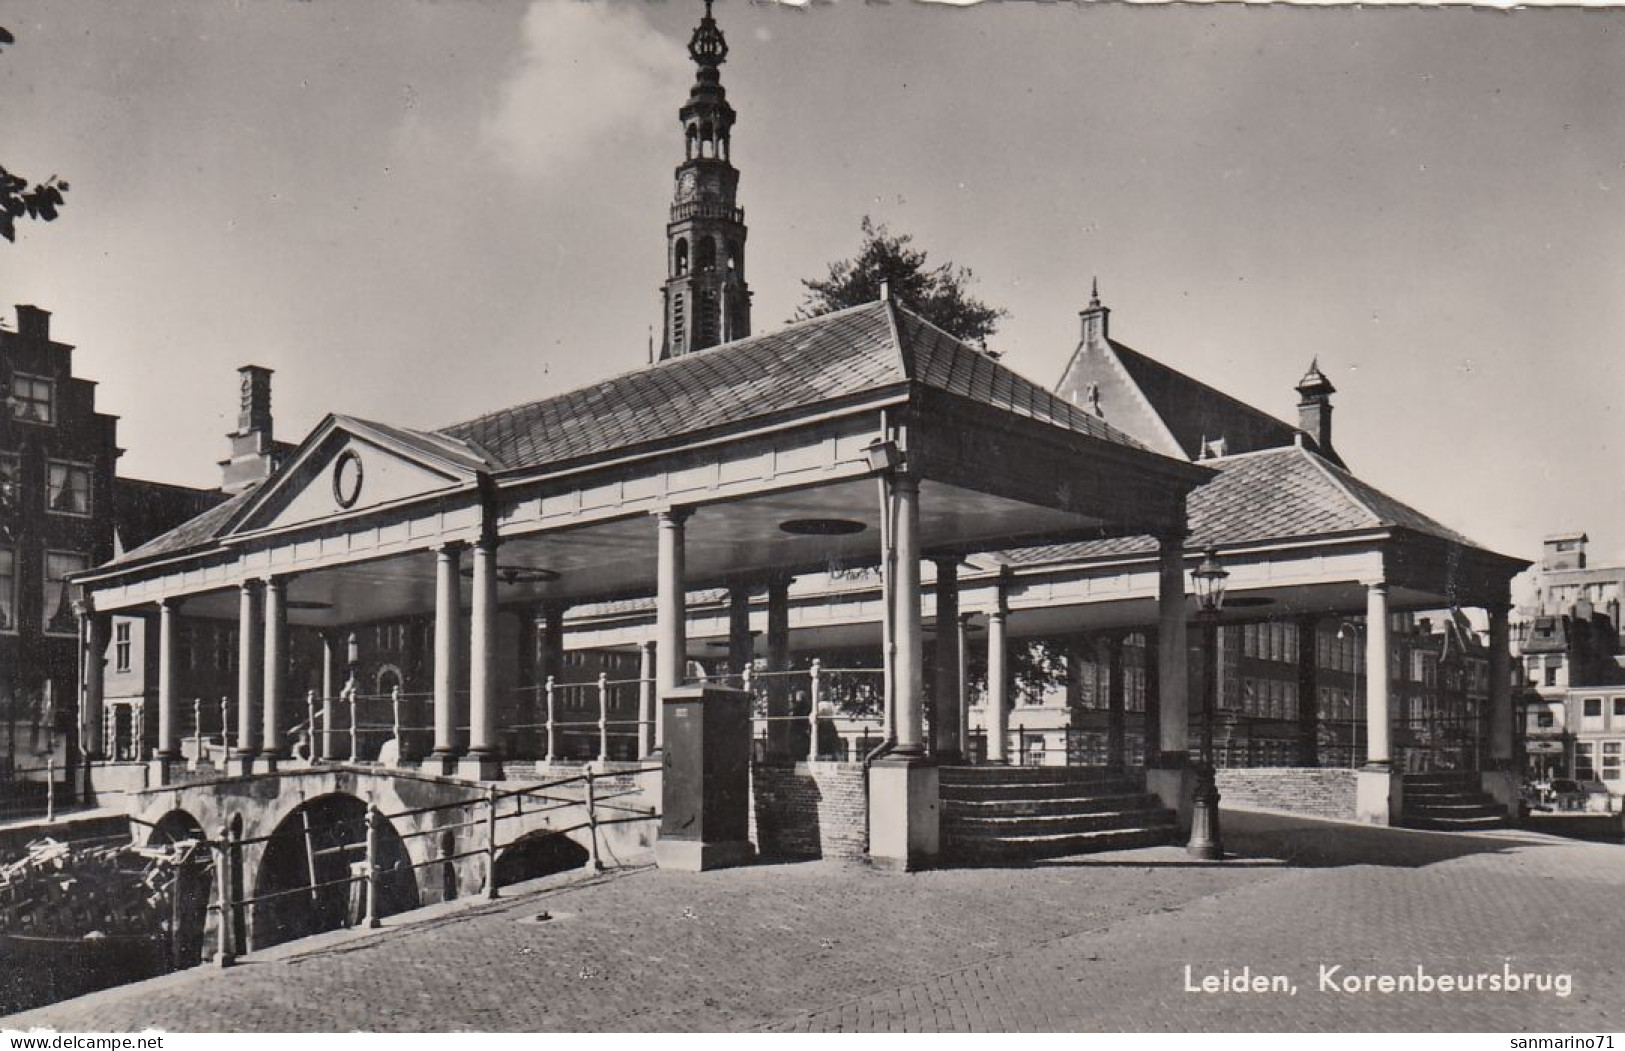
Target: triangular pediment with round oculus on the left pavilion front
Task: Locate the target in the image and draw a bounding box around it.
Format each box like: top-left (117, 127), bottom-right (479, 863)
top-left (229, 416), bottom-right (484, 534)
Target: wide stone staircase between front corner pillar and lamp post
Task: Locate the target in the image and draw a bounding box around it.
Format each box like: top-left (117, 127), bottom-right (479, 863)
top-left (941, 767), bottom-right (1178, 861)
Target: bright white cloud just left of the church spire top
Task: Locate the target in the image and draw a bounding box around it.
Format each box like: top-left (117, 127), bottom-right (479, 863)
top-left (481, 0), bottom-right (694, 175)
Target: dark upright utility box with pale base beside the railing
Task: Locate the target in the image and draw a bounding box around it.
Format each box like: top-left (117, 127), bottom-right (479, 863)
top-left (655, 686), bottom-right (751, 872)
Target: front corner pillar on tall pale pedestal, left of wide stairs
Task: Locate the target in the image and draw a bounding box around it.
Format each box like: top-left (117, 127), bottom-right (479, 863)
top-left (869, 474), bottom-right (939, 871)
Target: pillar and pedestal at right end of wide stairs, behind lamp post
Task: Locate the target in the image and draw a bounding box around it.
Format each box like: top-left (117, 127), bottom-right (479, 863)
top-left (1146, 536), bottom-right (1196, 832)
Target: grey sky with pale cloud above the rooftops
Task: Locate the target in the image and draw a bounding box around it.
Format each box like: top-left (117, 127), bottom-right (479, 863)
top-left (0, 0), bottom-right (1625, 591)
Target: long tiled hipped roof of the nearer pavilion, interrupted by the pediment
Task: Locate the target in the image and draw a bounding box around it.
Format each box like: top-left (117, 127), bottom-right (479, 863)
top-left (92, 302), bottom-right (1144, 562)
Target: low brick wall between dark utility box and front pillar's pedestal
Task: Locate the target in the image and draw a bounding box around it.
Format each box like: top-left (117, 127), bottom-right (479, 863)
top-left (751, 762), bottom-right (869, 858)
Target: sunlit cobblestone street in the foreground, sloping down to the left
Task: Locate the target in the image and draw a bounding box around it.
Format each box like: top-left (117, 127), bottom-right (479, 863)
top-left (5, 814), bottom-right (1625, 1032)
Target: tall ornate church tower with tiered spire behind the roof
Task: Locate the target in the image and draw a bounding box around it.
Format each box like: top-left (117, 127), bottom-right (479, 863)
top-left (660, 0), bottom-right (751, 361)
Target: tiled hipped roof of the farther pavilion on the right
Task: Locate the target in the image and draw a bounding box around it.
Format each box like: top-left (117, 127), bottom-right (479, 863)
top-left (1006, 445), bottom-right (1476, 565)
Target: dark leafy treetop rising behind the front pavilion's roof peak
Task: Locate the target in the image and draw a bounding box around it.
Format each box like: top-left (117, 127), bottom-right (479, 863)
top-left (796, 216), bottom-right (1009, 346)
